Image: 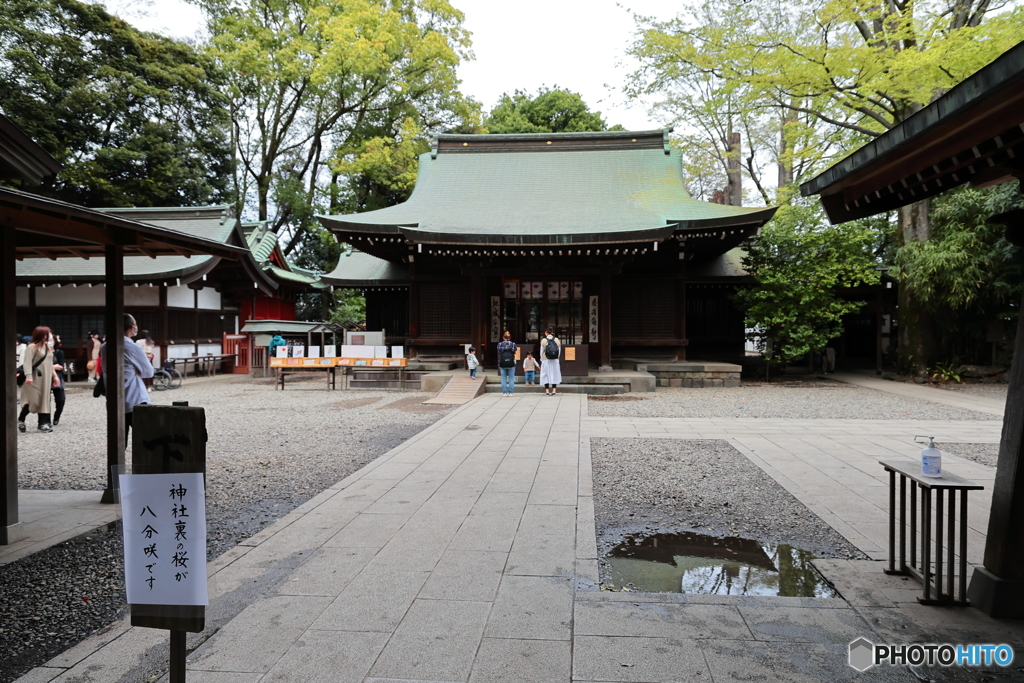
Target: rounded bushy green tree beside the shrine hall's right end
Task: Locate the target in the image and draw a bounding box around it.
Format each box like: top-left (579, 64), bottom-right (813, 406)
top-left (736, 200), bottom-right (879, 365)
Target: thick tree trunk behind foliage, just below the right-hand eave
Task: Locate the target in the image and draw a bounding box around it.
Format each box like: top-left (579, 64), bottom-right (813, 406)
top-left (897, 200), bottom-right (936, 375)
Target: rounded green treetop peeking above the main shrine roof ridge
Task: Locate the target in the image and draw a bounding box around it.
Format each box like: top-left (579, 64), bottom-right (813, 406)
top-left (483, 86), bottom-right (624, 133)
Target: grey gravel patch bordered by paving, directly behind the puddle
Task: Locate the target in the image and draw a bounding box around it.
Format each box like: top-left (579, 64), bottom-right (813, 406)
top-left (591, 440), bottom-right (866, 589)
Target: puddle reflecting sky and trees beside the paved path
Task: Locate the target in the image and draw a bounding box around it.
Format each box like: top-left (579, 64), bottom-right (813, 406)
top-left (601, 532), bottom-right (840, 598)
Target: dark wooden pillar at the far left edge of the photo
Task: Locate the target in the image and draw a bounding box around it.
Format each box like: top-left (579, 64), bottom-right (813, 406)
top-left (0, 227), bottom-right (25, 546)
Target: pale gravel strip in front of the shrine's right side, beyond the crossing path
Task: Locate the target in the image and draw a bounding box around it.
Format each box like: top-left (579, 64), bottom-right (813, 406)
top-left (588, 380), bottom-right (993, 420)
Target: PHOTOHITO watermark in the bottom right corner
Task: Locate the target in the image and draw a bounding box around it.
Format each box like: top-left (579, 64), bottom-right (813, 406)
top-left (850, 638), bottom-right (1014, 671)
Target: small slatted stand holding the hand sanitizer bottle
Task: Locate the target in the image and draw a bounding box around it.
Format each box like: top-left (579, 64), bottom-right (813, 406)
top-left (879, 460), bottom-right (984, 605)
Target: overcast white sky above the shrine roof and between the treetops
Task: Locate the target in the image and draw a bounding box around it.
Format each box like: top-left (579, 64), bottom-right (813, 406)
top-left (105, 0), bottom-right (685, 130)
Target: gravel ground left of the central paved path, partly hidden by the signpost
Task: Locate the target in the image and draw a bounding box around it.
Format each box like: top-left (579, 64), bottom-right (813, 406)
top-left (0, 377), bottom-right (452, 683)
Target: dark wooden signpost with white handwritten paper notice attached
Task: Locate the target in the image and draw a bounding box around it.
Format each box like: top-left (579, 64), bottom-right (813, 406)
top-left (121, 401), bottom-right (209, 683)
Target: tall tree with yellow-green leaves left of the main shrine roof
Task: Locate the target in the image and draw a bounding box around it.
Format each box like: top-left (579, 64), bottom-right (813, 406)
top-left (195, 0), bottom-right (472, 259)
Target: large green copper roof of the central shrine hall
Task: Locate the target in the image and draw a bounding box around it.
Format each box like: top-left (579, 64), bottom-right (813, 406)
top-left (321, 132), bottom-right (774, 244)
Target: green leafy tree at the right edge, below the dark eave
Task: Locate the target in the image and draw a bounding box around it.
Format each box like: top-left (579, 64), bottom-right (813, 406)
top-left (890, 182), bottom-right (1024, 364)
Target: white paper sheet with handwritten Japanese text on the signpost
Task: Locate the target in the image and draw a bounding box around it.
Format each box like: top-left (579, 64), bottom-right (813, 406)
top-left (120, 472), bottom-right (210, 605)
